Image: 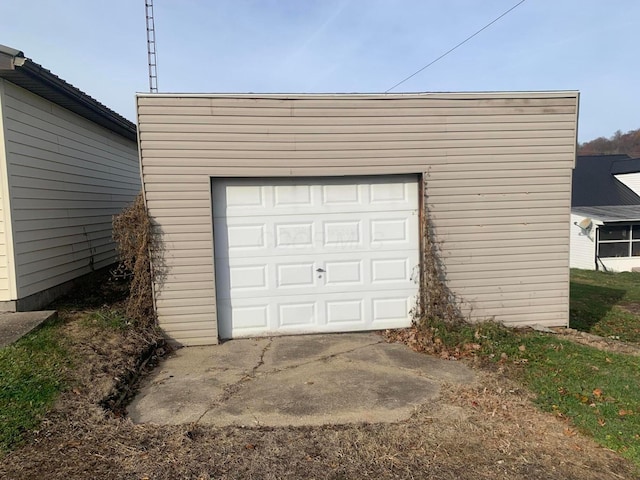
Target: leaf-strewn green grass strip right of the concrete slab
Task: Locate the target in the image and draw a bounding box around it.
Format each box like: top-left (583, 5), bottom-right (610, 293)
top-left (420, 322), bottom-right (640, 471)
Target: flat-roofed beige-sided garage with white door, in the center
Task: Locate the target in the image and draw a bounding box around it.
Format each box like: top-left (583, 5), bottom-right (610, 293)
top-left (137, 92), bottom-right (578, 345)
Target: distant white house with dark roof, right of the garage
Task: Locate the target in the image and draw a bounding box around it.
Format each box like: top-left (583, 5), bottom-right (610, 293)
top-left (570, 155), bottom-right (640, 271)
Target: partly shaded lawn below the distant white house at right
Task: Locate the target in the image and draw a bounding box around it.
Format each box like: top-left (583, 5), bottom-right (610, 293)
top-left (569, 270), bottom-right (640, 343)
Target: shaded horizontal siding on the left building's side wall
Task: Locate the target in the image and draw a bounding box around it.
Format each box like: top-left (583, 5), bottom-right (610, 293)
top-left (4, 82), bottom-right (140, 298)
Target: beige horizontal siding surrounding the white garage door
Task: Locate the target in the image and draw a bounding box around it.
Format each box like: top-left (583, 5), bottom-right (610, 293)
top-left (138, 92), bottom-right (578, 345)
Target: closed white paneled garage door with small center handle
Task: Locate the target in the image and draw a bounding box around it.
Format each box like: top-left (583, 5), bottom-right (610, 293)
top-left (212, 176), bottom-right (420, 338)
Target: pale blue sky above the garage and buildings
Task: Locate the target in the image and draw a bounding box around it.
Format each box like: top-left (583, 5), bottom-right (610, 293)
top-left (0, 0), bottom-right (640, 141)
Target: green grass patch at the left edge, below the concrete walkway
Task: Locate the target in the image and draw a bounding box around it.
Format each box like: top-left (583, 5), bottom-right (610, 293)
top-left (0, 322), bottom-right (69, 452)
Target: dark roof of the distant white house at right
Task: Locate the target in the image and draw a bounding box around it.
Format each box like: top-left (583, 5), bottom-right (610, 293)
top-left (571, 154), bottom-right (640, 207)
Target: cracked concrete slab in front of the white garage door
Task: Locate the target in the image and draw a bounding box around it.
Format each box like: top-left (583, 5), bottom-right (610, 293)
top-left (129, 333), bottom-right (475, 426)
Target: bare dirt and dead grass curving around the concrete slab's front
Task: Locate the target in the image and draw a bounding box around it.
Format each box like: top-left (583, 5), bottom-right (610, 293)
top-left (0, 314), bottom-right (636, 480)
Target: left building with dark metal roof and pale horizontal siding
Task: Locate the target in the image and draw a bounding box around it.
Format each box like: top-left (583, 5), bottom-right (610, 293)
top-left (0, 46), bottom-right (140, 311)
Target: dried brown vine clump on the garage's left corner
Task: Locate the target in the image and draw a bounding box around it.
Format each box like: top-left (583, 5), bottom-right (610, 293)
top-left (113, 193), bottom-right (157, 325)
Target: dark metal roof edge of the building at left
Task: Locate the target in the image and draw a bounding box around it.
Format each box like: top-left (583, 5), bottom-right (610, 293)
top-left (0, 45), bottom-right (136, 140)
